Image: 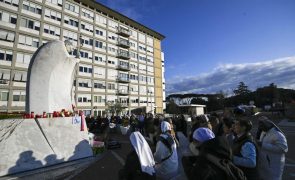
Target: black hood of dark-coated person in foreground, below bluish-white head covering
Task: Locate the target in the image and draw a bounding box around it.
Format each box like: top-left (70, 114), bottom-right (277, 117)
top-left (200, 136), bottom-right (232, 159)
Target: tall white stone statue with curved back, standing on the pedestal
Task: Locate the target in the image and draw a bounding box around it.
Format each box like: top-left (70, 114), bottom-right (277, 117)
top-left (26, 40), bottom-right (79, 114)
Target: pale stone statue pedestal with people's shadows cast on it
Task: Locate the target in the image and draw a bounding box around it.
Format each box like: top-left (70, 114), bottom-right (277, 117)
top-left (0, 117), bottom-right (93, 176)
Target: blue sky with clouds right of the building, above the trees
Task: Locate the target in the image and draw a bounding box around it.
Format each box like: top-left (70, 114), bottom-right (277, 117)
top-left (98, 0), bottom-right (295, 93)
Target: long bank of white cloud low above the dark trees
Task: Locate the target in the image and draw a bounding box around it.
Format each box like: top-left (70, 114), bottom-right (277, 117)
top-left (166, 57), bottom-right (295, 94)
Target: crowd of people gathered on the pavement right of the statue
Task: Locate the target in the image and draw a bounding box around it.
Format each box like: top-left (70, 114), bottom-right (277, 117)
top-left (88, 114), bottom-right (288, 180)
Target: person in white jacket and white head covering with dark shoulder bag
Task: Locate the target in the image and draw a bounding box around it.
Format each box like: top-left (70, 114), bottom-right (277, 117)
top-left (154, 121), bottom-right (178, 180)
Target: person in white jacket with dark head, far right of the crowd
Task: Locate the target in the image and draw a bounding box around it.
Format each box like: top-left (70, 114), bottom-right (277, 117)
top-left (258, 116), bottom-right (288, 180)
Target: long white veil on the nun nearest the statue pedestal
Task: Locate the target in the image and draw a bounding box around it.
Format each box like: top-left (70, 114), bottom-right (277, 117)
top-left (130, 131), bottom-right (155, 175)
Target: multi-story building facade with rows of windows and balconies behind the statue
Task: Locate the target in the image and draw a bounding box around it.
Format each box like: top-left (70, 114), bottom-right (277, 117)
top-left (0, 0), bottom-right (165, 115)
